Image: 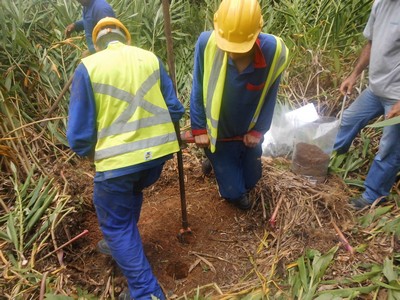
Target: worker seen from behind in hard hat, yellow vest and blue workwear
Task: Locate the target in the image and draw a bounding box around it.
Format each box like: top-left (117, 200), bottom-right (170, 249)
top-left (67, 18), bottom-right (184, 299)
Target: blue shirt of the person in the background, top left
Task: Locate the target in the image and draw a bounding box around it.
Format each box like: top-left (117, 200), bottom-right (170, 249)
top-left (75, 0), bottom-right (115, 53)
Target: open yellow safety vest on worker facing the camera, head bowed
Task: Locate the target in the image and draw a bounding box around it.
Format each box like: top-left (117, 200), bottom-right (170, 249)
top-left (203, 31), bottom-right (289, 152)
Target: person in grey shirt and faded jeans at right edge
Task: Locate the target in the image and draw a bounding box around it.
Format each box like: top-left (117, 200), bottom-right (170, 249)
top-left (334, 0), bottom-right (400, 210)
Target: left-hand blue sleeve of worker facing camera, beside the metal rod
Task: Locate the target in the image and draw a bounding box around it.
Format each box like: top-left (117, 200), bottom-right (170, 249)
top-left (190, 32), bottom-right (211, 130)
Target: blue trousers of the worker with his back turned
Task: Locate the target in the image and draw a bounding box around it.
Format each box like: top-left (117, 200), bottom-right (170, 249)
top-left (93, 164), bottom-right (165, 300)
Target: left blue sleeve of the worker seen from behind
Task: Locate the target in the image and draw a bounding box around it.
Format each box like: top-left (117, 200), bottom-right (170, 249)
top-left (67, 63), bottom-right (97, 156)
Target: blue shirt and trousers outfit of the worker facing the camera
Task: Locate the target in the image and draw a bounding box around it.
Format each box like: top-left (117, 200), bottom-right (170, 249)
top-left (190, 31), bottom-right (280, 202)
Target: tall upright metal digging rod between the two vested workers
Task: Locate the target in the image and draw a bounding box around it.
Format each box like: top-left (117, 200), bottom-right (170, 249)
top-left (162, 0), bottom-right (192, 243)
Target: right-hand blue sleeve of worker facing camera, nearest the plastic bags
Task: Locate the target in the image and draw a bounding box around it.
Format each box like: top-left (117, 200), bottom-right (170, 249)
top-left (253, 75), bottom-right (281, 134)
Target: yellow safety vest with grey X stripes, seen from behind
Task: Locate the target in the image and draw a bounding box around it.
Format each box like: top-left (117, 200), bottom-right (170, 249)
top-left (82, 43), bottom-right (179, 172)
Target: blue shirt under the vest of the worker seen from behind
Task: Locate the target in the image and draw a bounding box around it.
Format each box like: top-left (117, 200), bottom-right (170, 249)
top-left (67, 52), bottom-right (185, 181)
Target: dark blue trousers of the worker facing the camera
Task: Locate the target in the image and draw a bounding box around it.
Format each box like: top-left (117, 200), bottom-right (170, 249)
top-left (205, 141), bottom-right (262, 202)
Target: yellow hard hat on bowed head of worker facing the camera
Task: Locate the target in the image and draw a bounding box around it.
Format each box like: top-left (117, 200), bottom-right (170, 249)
top-left (214, 0), bottom-right (263, 53)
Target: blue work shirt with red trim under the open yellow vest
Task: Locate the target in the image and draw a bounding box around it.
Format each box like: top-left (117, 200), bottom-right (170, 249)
top-left (190, 31), bottom-right (280, 138)
